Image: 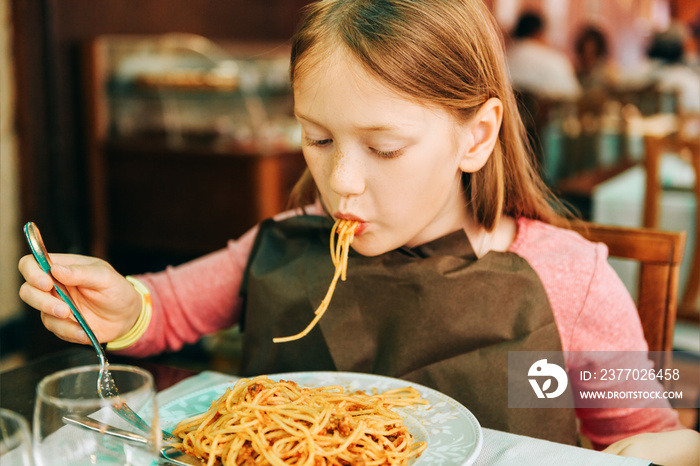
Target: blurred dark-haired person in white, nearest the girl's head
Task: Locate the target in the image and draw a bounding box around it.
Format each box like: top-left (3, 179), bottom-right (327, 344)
top-left (507, 11), bottom-right (581, 100)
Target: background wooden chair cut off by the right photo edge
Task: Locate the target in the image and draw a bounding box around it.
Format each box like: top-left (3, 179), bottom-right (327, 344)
top-left (644, 115), bottom-right (700, 323)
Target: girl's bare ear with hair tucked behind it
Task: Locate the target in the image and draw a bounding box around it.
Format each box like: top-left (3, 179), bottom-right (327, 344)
top-left (459, 98), bottom-right (503, 173)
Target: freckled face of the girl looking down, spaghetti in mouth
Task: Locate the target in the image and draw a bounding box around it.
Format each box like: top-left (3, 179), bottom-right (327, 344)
top-left (294, 53), bottom-right (470, 256)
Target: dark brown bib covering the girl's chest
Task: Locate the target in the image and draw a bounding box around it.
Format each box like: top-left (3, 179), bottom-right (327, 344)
top-left (242, 216), bottom-right (577, 444)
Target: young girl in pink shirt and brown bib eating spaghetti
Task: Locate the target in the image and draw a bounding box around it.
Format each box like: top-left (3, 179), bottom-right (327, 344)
top-left (20, 0), bottom-right (696, 462)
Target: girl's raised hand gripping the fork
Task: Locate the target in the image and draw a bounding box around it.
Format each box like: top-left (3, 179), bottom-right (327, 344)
top-left (19, 254), bottom-right (141, 344)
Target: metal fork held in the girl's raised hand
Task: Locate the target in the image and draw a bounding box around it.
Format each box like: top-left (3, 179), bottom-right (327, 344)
top-left (24, 222), bottom-right (179, 442)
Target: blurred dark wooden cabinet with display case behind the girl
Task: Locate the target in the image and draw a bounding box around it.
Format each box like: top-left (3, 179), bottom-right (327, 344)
top-left (85, 35), bottom-right (305, 274)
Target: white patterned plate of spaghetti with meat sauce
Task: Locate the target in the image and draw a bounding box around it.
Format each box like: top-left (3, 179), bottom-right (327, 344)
top-left (159, 372), bottom-right (483, 466)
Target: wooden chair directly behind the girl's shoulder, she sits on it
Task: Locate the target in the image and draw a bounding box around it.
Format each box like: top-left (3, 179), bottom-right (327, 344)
top-left (572, 222), bottom-right (686, 368)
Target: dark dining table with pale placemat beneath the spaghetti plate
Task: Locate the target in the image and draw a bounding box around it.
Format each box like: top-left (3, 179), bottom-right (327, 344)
top-left (0, 346), bottom-right (649, 466)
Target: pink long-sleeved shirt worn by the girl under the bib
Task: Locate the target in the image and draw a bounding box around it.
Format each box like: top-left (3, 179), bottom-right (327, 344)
top-left (120, 213), bottom-right (681, 447)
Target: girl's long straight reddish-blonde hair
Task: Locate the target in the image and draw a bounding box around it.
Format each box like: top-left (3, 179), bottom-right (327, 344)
top-left (290, 0), bottom-right (567, 230)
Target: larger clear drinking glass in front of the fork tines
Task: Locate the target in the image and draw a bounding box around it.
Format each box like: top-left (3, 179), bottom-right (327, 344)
top-left (33, 364), bottom-right (161, 466)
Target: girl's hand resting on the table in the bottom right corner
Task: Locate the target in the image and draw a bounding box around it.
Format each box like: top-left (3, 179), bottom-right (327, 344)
top-left (603, 429), bottom-right (700, 466)
